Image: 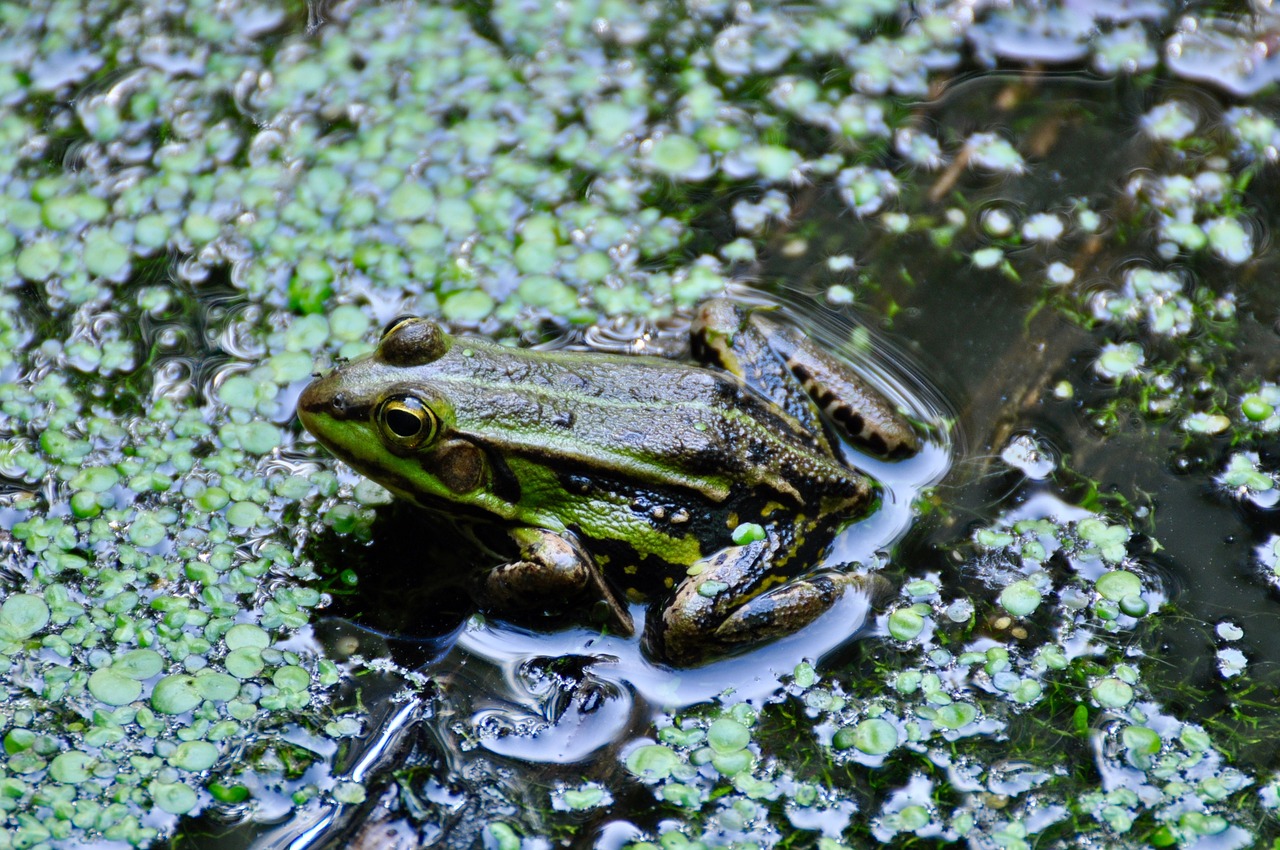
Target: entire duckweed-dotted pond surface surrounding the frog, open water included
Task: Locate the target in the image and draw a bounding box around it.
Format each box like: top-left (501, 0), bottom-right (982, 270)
top-left (0, 0), bottom-right (1280, 850)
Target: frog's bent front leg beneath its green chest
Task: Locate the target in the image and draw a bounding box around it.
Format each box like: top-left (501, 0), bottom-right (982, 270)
top-left (479, 529), bottom-right (635, 636)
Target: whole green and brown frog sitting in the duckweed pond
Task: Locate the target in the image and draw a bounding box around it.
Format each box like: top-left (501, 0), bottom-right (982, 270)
top-left (298, 300), bottom-right (919, 664)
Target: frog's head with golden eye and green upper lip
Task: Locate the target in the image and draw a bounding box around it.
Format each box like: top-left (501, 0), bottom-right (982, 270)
top-left (298, 319), bottom-right (485, 504)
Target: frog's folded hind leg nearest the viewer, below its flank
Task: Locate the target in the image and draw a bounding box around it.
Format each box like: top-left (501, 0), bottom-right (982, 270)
top-left (645, 535), bottom-right (883, 664)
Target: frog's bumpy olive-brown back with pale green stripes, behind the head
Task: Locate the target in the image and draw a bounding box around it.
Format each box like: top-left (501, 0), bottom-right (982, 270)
top-left (431, 339), bottom-right (873, 509)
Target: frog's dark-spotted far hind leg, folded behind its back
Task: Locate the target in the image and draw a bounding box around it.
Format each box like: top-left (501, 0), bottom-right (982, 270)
top-left (692, 298), bottom-right (920, 458)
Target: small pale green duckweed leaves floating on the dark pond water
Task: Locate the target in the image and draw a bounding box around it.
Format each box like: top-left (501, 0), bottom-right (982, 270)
top-left (0, 0), bottom-right (1280, 850)
